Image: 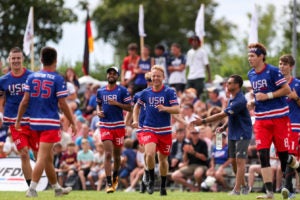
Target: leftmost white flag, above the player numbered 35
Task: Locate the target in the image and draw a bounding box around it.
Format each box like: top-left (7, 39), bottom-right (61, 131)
top-left (23, 7), bottom-right (34, 56)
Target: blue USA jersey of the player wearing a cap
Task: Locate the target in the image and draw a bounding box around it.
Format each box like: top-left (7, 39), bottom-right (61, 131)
top-left (97, 85), bottom-right (131, 129)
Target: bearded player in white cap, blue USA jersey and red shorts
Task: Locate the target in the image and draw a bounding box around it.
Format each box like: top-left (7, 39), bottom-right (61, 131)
top-left (97, 67), bottom-right (131, 193)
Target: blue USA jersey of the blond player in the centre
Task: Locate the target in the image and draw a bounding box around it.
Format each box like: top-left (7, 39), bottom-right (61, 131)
top-left (138, 86), bottom-right (178, 134)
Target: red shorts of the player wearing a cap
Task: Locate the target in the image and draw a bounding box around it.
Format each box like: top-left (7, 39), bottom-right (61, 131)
top-left (100, 128), bottom-right (125, 147)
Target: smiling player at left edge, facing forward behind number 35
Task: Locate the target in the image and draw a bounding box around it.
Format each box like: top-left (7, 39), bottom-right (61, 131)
top-left (0, 47), bottom-right (38, 186)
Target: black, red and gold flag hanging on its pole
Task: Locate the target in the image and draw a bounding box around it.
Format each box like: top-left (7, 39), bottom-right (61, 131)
top-left (82, 13), bottom-right (94, 75)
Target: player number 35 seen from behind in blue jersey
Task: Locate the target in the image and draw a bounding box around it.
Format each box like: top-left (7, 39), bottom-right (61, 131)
top-left (15, 47), bottom-right (76, 197)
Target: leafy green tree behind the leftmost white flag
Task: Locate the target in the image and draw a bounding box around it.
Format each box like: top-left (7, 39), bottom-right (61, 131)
top-left (0, 0), bottom-right (77, 57)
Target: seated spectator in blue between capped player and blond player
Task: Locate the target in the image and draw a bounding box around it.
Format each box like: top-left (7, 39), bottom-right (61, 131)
top-left (119, 138), bottom-right (136, 188)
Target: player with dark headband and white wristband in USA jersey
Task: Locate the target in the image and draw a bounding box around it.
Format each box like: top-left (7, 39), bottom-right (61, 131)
top-left (248, 43), bottom-right (291, 199)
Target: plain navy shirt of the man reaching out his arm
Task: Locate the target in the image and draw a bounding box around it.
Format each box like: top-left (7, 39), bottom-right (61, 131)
top-left (224, 91), bottom-right (252, 140)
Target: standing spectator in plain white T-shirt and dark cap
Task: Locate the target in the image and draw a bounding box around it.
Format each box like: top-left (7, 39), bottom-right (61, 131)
top-left (186, 36), bottom-right (211, 97)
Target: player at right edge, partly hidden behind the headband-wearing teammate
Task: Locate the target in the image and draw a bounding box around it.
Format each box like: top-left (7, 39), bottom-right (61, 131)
top-left (279, 55), bottom-right (300, 199)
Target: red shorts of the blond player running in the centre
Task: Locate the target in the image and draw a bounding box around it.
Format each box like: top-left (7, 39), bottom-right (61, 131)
top-left (141, 132), bottom-right (172, 156)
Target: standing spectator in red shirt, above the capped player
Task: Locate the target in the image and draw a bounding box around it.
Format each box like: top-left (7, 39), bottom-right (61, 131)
top-left (121, 43), bottom-right (140, 87)
